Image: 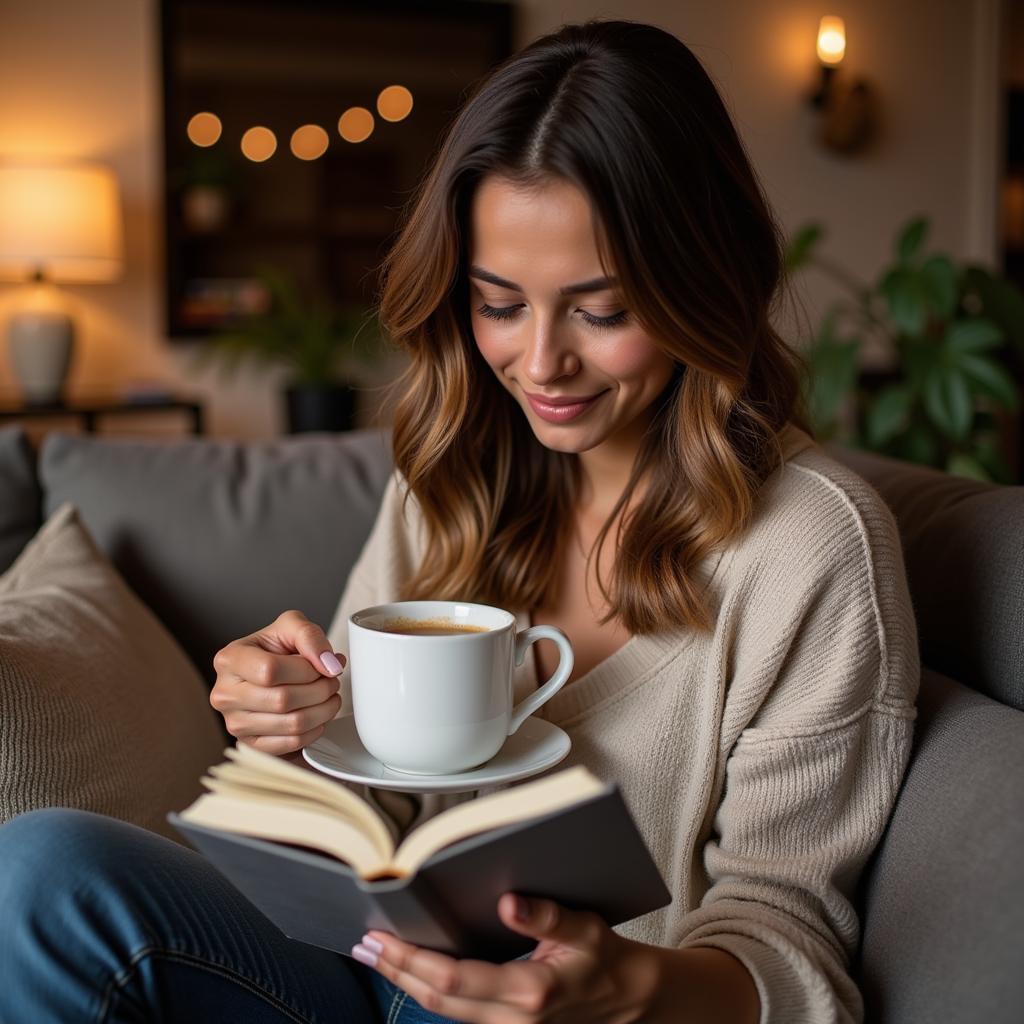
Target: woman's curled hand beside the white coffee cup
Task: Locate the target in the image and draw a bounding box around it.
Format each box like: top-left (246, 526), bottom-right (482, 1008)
top-left (210, 610), bottom-right (345, 760)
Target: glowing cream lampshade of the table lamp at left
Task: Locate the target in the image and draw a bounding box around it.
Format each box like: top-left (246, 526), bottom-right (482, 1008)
top-left (0, 164), bottom-right (123, 282)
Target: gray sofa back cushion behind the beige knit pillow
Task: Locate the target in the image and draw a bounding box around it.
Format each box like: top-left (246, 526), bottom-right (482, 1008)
top-left (39, 430), bottom-right (391, 683)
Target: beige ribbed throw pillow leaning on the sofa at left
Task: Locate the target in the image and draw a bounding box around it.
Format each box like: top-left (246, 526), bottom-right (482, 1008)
top-left (0, 502), bottom-right (227, 842)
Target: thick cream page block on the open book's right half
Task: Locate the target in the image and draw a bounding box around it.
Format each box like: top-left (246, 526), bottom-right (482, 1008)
top-left (392, 765), bottom-right (606, 873)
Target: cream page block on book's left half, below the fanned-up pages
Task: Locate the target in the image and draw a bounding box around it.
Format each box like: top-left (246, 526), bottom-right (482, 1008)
top-left (179, 794), bottom-right (389, 878)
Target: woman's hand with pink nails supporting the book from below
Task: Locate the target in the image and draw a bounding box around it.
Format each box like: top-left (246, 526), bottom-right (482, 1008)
top-left (353, 893), bottom-right (658, 1024)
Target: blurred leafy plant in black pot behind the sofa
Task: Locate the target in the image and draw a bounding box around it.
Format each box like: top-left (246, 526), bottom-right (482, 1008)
top-left (185, 266), bottom-right (382, 433)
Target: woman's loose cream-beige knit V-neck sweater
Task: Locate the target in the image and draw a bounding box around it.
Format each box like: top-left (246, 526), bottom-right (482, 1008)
top-left (328, 426), bottom-right (920, 1024)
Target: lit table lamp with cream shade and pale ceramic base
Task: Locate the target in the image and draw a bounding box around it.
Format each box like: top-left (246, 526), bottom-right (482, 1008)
top-left (0, 164), bottom-right (123, 404)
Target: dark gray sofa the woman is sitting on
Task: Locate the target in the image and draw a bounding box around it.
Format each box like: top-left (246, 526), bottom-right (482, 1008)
top-left (0, 426), bottom-right (1024, 1024)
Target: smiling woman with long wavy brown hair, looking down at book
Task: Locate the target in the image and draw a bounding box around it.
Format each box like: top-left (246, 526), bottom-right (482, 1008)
top-left (0, 22), bottom-right (919, 1024)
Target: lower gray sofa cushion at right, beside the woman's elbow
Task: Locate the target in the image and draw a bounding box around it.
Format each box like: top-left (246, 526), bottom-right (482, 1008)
top-left (860, 671), bottom-right (1024, 1024)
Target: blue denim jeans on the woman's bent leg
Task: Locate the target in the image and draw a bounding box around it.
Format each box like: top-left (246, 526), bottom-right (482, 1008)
top-left (0, 808), bottom-right (481, 1024)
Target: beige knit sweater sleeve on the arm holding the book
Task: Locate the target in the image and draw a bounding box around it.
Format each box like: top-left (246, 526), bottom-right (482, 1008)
top-left (678, 473), bottom-right (920, 1024)
